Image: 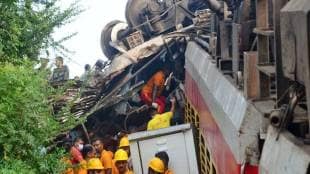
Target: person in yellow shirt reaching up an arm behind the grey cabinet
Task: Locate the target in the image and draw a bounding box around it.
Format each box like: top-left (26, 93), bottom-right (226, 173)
top-left (147, 98), bottom-right (176, 130)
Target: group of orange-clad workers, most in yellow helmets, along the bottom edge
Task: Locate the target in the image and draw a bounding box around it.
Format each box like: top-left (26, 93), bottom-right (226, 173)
top-left (64, 135), bottom-right (173, 174)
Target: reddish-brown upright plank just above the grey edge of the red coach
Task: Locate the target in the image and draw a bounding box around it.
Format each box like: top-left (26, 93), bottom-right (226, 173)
top-left (244, 51), bottom-right (259, 99)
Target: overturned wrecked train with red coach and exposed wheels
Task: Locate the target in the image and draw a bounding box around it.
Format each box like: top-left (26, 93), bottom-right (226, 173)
top-left (60, 0), bottom-right (310, 174)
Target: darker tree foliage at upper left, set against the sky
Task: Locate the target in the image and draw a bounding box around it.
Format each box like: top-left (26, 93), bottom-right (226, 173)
top-left (0, 0), bottom-right (81, 64)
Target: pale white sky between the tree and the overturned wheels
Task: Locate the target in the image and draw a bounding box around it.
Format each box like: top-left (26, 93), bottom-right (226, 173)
top-left (50, 0), bottom-right (127, 78)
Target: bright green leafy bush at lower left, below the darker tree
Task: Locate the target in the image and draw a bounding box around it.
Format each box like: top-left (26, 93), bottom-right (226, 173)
top-left (0, 63), bottom-right (74, 174)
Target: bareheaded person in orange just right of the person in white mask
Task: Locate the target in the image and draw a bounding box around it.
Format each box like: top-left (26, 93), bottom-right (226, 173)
top-left (77, 144), bottom-right (96, 174)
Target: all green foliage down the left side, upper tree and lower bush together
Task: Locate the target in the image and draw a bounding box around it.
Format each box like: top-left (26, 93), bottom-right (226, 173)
top-left (0, 0), bottom-right (85, 174)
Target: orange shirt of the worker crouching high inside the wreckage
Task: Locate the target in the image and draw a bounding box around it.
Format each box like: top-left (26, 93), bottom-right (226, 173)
top-left (141, 71), bottom-right (165, 97)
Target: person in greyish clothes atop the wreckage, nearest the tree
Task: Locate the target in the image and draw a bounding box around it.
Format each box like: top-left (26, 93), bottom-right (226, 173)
top-left (50, 56), bottom-right (69, 83)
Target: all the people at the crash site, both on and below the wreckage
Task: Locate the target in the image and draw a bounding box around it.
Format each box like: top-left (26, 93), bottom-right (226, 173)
top-left (43, 57), bottom-right (176, 174)
